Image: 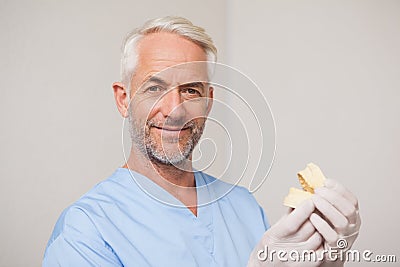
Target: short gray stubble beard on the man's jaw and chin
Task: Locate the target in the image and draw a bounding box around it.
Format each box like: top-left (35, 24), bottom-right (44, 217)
top-left (129, 112), bottom-right (205, 166)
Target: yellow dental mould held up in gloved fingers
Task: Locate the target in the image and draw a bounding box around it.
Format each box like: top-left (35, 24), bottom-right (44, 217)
top-left (283, 163), bottom-right (326, 208)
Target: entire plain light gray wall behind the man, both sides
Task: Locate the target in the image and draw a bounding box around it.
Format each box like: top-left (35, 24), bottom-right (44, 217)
top-left (0, 0), bottom-right (400, 266)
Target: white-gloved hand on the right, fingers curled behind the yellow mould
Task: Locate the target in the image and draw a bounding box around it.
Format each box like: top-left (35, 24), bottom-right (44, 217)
top-left (310, 179), bottom-right (361, 266)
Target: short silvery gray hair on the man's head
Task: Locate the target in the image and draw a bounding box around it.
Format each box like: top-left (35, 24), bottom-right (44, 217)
top-left (121, 16), bottom-right (217, 90)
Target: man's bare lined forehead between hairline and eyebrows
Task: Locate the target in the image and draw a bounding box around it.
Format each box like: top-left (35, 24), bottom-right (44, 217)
top-left (135, 32), bottom-right (207, 86)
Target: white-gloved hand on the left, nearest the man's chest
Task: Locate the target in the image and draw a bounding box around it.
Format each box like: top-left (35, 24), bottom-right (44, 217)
top-left (247, 199), bottom-right (323, 267)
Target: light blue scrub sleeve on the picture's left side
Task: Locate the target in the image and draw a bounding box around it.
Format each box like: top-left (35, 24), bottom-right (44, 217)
top-left (42, 207), bottom-right (122, 267)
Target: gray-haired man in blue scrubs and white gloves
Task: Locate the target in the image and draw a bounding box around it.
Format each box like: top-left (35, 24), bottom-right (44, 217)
top-left (43, 17), bottom-right (360, 266)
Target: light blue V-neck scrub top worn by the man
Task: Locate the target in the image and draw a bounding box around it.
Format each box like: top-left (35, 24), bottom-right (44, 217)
top-left (43, 168), bottom-right (269, 267)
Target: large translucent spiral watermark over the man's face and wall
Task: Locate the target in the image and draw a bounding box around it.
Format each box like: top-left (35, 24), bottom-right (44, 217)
top-left (122, 62), bottom-right (276, 206)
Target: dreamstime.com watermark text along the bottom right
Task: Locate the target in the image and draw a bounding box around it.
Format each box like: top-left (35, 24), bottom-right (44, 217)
top-left (257, 238), bottom-right (397, 263)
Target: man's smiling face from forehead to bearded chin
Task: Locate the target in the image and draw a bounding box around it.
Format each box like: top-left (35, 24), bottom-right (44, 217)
top-left (129, 33), bottom-right (213, 165)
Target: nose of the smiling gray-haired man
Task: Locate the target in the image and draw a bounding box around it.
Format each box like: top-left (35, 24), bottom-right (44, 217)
top-left (158, 88), bottom-right (186, 119)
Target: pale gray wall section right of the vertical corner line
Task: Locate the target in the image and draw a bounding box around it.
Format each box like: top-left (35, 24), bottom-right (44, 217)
top-left (226, 0), bottom-right (400, 266)
